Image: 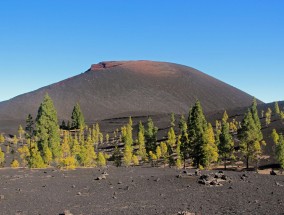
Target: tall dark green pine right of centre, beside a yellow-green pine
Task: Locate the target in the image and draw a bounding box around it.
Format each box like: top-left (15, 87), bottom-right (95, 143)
top-left (188, 101), bottom-right (207, 168)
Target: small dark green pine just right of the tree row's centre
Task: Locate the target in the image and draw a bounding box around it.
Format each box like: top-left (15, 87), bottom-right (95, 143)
top-left (145, 117), bottom-right (158, 154)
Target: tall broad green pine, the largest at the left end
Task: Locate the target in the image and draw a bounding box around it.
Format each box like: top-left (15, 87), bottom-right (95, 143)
top-left (35, 94), bottom-right (61, 158)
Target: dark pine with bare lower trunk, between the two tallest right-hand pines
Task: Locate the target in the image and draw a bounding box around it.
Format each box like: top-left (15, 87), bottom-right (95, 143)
top-left (218, 120), bottom-right (234, 169)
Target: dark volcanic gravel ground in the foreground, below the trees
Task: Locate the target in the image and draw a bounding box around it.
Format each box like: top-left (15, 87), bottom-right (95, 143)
top-left (0, 167), bottom-right (284, 215)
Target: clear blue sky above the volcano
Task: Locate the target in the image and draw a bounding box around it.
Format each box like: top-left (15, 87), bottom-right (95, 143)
top-left (0, 0), bottom-right (284, 102)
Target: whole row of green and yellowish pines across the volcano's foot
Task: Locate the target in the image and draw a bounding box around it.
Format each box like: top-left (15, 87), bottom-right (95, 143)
top-left (0, 95), bottom-right (284, 169)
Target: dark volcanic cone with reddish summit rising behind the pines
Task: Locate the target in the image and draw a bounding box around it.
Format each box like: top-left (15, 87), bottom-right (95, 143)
top-left (0, 61), bottom-right (258, 124)
